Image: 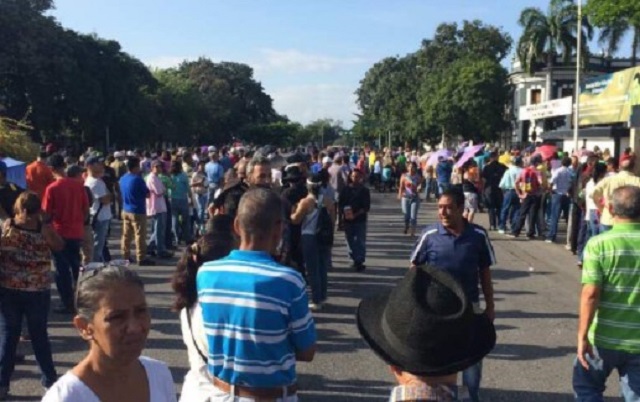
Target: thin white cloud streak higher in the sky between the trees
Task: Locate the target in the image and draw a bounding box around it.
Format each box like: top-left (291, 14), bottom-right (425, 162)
top-left (255, 49), bottom-right (369, 73)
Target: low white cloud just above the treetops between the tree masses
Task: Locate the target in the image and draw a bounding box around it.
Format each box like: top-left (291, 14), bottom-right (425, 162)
top-left (271, 84), bottom-right (358, 127)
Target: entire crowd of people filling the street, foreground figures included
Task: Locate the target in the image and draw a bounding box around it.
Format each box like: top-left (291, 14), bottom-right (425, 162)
top-left (0, 140), bottom-right (640, 402)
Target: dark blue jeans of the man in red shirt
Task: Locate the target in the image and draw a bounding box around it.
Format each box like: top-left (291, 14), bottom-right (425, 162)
top-left (53, 239), bottom-right (82, 310)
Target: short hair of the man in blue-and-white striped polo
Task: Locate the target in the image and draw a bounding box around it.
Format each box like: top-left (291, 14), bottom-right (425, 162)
top-left (237, 188), bottom-right (284, 238)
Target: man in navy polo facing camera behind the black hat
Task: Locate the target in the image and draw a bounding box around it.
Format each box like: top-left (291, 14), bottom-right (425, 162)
top-left (411, 188), bottom-right (496, 402)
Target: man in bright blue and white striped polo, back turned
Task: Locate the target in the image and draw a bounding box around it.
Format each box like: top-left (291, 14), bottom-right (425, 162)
top-left (197, 188), bottom-right (316, 402)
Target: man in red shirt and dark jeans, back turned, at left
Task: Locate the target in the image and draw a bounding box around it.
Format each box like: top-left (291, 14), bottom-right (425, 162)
top-left (42, 154), bottom-right (89, 314)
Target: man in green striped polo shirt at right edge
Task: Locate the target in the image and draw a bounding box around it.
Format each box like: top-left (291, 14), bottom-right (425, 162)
top-left (573, 186), bottom-right (640, 402)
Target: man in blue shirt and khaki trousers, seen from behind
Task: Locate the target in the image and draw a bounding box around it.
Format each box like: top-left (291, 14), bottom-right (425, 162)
top-left (119, 157), bottom-right (155, 266)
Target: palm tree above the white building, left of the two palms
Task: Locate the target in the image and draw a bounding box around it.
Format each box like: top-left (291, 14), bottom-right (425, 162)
top-left (517, 0), bottom-right (593, 74)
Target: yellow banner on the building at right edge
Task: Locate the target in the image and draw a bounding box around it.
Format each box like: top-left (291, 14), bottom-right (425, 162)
top-left (580, 67), bottom-right (640, 126)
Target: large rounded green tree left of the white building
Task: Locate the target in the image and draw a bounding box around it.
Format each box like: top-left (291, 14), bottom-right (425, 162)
top-left (353, 21), bottom-right (512, 144)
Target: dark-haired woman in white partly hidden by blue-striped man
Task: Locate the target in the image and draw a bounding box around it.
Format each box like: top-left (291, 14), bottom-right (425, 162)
top-left (171, 215), bottom-right (236, 402)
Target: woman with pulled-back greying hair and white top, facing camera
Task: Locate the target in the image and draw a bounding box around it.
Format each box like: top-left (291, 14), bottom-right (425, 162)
top-left (42, 264), bottom-right (176, 402)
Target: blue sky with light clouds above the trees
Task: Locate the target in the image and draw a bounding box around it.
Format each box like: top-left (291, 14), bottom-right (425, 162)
top-left (51, 0), bottom-right (630, 126)
